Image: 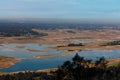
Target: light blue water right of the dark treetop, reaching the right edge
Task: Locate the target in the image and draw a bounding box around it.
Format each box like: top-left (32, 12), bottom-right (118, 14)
top-left (79, 50), bottom-right (120, 60)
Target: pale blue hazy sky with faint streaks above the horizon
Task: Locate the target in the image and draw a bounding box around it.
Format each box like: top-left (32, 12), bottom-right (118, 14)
top-left (0, 0), bottom-right (120, 19)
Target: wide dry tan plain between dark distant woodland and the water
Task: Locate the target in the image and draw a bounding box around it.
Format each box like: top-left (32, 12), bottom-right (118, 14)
top-left (0, 29), bottom-right (120, 44)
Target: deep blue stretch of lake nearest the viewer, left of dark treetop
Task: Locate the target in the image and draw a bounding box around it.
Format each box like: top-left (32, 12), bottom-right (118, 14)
top-left (0, 57), bottom-right (70, 72)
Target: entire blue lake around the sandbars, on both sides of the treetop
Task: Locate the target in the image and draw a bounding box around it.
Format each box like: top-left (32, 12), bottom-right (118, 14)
top-left (0, 44), bottom-right (120, 72)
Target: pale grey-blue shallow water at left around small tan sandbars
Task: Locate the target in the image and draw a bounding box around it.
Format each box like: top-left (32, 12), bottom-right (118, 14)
top-left (0, 44), bottom-right (62, 59)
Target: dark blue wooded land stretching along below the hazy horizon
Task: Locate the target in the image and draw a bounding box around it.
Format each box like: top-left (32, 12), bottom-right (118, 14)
top-left (0, 22), bottom-right (120, 36)
